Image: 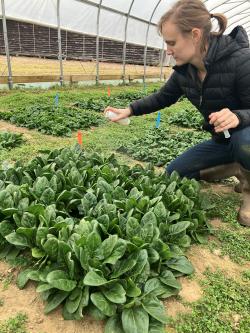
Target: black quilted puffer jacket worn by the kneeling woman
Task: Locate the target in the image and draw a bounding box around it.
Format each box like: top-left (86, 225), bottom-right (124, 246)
top-left (130, 26), bottom-right (250, 139)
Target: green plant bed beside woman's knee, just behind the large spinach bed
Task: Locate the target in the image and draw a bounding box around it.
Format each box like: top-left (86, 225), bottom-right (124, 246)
top-left (117, 128), bottom-right (210, 166)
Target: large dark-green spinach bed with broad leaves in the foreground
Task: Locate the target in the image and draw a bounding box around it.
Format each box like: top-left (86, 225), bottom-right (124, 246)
top-left (0, 147), bottom-right (209, 333)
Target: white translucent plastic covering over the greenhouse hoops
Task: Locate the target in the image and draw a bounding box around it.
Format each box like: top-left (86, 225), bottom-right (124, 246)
top-left (0, 0), bottom-right (250, 49)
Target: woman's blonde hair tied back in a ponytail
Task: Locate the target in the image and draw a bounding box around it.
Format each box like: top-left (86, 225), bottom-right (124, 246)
top-left (158, 0), bottom-right (227, 52)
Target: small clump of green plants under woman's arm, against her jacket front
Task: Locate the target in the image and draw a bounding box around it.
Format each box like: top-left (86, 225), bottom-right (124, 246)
top-left (168, 106), bottom-right (203, 130)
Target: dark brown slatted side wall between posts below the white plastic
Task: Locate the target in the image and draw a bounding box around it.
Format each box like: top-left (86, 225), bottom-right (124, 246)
top-left (0, 20), bottom-right (161, 66)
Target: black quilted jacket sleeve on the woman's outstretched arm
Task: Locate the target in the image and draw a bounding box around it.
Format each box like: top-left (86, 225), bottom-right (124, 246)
top-left (130, 72), bottom-right (183, 116)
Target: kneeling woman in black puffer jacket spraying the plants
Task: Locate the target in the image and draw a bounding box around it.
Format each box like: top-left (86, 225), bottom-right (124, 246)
top-left (105, 0), bottom-right (250, 226)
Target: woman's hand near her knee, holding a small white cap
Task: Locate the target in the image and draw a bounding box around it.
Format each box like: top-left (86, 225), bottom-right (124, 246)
top-left (209, 108), bottom-right (240, 133)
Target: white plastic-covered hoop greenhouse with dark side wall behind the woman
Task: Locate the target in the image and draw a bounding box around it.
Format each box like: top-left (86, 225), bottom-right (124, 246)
top-left (0, 0), bottom-right (250, 88)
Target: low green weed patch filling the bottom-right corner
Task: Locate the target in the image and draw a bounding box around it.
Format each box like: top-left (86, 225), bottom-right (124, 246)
top-left (171, 270), bottom-right (250, 333)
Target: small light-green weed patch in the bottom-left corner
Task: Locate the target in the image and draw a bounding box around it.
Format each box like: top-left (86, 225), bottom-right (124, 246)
top-left (0, 313), bottom-right (28, 333)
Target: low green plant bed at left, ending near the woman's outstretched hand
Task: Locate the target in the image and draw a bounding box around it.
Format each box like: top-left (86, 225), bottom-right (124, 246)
top-left (0, 104), bottom-right (105, 136)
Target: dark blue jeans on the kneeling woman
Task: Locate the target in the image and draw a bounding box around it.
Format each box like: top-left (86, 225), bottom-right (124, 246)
top-left (166, 126), bottom-right (250, 180)
